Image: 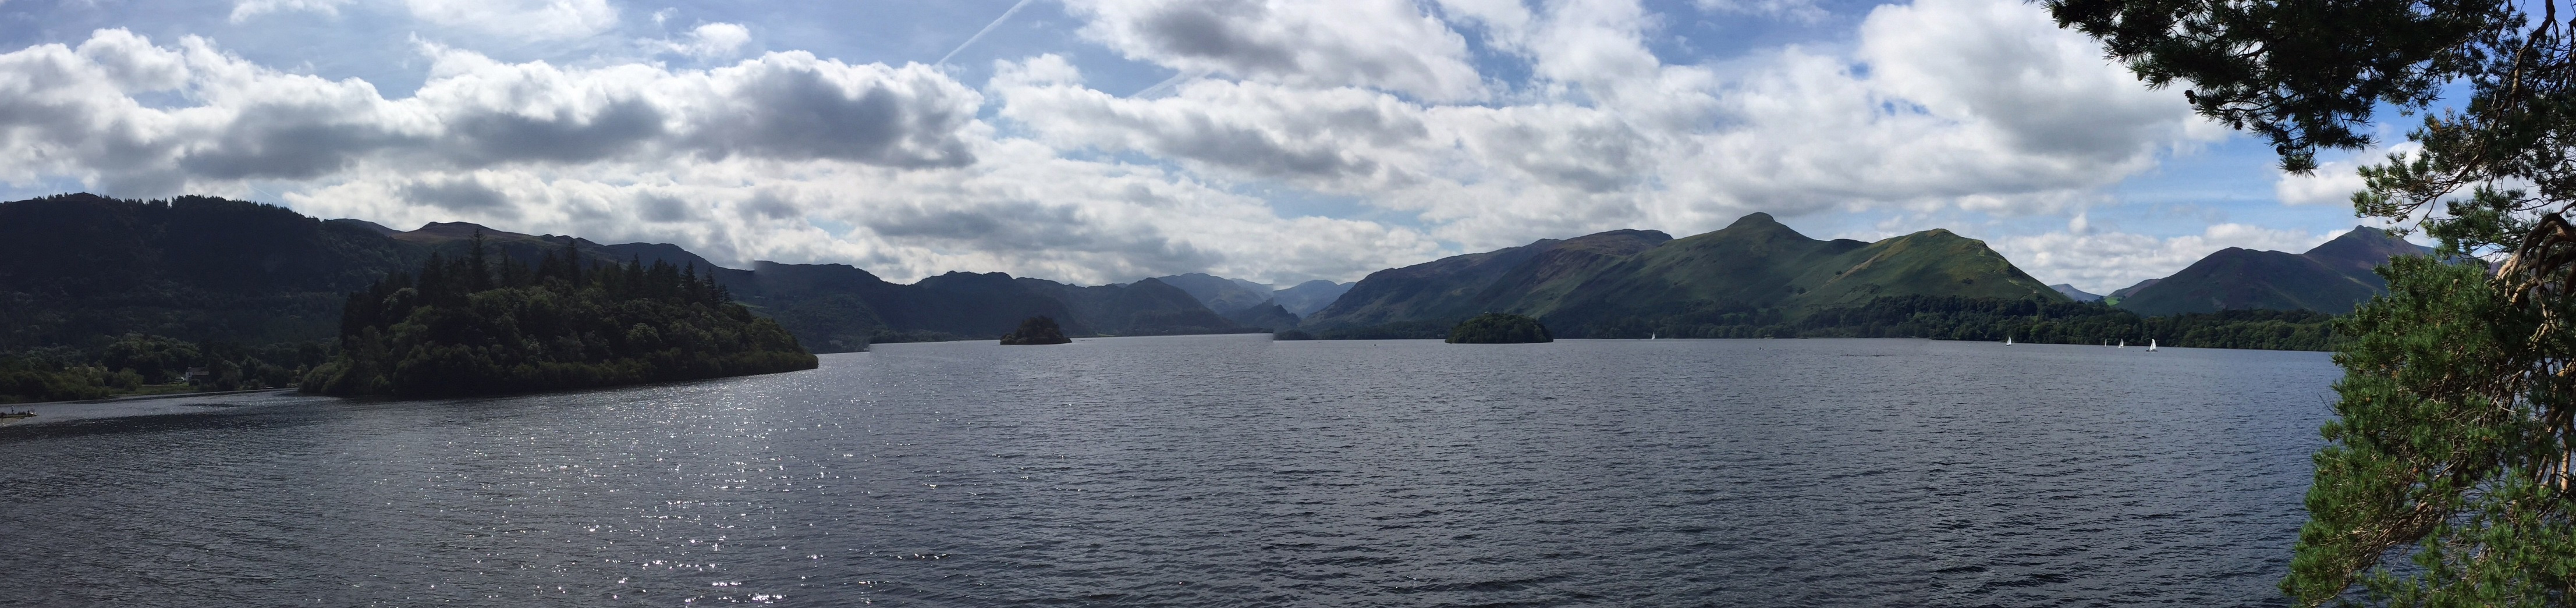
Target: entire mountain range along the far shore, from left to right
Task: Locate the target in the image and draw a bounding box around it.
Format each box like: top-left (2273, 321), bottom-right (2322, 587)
top-left (0, 193), bottom-right (2424, 353)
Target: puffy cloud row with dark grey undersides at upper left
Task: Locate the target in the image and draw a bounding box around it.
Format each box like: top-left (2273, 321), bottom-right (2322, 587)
top-left (0, 31), bottom-right (981, 196)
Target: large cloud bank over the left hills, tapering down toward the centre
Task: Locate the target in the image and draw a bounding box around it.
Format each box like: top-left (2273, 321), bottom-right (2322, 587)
top-left (0, 31), bottom-right (1438, 283)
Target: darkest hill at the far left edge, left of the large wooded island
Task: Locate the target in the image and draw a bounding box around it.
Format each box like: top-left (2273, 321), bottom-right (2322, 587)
top-left (0, 193), bottom-right (425, 348)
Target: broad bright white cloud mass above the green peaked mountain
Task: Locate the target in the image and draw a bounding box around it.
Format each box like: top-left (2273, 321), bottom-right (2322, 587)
top-left (987, 0), bottom-right (2223, 250)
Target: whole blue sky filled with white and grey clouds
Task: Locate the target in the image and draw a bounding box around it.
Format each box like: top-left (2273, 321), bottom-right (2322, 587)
top-left (0, 0), bottom-right (2378, 291)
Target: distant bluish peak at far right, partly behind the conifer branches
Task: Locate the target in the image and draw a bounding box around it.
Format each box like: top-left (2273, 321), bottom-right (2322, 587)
top-left (2117, 227), bottom-right (2432, 317)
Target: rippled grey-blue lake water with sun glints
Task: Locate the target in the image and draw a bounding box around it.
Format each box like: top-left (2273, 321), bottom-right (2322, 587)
top-left (0, 335), bottom-right (2339, 606)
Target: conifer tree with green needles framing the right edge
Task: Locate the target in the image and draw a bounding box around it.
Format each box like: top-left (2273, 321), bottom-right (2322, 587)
top-left (2048, 0), bottom-right (2576, 606)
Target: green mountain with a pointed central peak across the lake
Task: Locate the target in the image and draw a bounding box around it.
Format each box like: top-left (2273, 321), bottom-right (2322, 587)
top-left (1306, 214), bottom-right (2066, 337)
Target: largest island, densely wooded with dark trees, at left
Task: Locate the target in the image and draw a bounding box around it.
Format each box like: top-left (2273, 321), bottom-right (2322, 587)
top-left (301, 237), bottom-right (817, 397)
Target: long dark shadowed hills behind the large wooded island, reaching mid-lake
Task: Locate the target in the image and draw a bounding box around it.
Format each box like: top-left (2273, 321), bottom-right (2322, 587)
top-left (0, 193), bottom-right (1259, 353)
